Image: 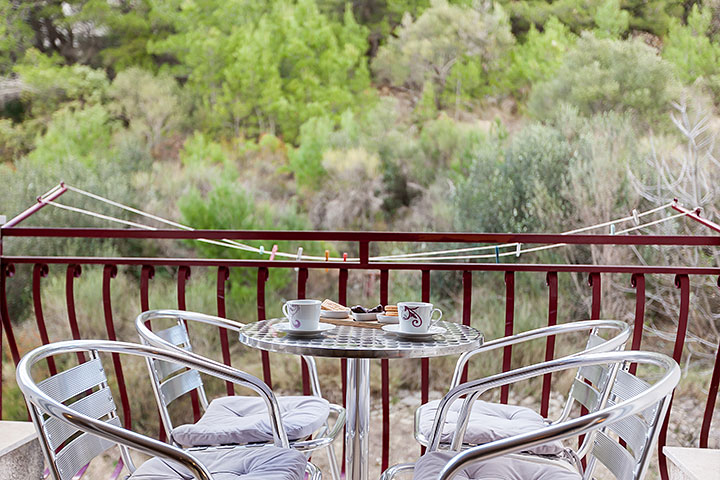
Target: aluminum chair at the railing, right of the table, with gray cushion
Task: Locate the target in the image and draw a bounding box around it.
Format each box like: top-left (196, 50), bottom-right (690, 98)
top-left (415, 320), bottom-right (631, 455)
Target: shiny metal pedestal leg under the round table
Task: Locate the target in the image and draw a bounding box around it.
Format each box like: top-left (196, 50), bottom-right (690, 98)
top-left (345, 358), bottom-right (370, 480)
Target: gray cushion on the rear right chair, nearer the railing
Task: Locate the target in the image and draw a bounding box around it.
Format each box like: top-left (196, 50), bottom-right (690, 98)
top-left (418, 400), bottom-right (563, 455)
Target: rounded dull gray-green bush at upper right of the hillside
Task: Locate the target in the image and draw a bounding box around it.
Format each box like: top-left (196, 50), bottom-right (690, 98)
top-left (528, 34), bottom-right (676, 124)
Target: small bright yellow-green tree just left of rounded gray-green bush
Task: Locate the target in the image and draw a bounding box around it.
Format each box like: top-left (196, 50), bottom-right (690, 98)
top-left (491, 17), bottom-right (577, 98)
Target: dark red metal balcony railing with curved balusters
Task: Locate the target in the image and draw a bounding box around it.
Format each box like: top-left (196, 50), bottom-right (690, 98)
top-left (0, 227), bottom-right (720, 479)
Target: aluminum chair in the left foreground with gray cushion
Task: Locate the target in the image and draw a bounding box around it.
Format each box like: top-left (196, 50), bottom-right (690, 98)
top-left (17, 340), bottom-right (321, 480)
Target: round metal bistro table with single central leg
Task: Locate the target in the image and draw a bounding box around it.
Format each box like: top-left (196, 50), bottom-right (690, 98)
top-left (240, 318), bottom-right (483, 480)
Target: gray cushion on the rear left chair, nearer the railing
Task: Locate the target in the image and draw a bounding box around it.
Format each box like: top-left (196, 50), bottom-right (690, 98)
top-left (172, 396), bottom-right (330, 447)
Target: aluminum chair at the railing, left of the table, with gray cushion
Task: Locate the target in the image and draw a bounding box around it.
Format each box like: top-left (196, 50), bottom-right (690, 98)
top-left (135, 310), bottom-right (345, 480)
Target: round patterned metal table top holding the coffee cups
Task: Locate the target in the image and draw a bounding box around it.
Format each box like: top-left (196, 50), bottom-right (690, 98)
top-left (239, 318), bottom-right (483, 358)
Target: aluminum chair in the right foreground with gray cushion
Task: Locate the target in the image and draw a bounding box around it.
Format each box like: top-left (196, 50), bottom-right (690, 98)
top-left (381, 352), bottom-right (680, 480)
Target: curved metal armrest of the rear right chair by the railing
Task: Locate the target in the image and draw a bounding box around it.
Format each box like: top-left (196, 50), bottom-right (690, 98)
top-left (450, 320), bottom-right (630, 389)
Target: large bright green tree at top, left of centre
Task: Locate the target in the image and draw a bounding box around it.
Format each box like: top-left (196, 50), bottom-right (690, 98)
top-left (152, 0), bottom-right (369, 141)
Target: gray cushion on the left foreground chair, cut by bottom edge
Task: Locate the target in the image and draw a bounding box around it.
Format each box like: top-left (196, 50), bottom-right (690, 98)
top-left (130, 447), bottom-right (307, 480)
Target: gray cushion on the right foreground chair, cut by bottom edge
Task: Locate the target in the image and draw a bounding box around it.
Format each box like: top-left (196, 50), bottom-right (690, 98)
top-left (413, 451), bottom-right (582, 480)
